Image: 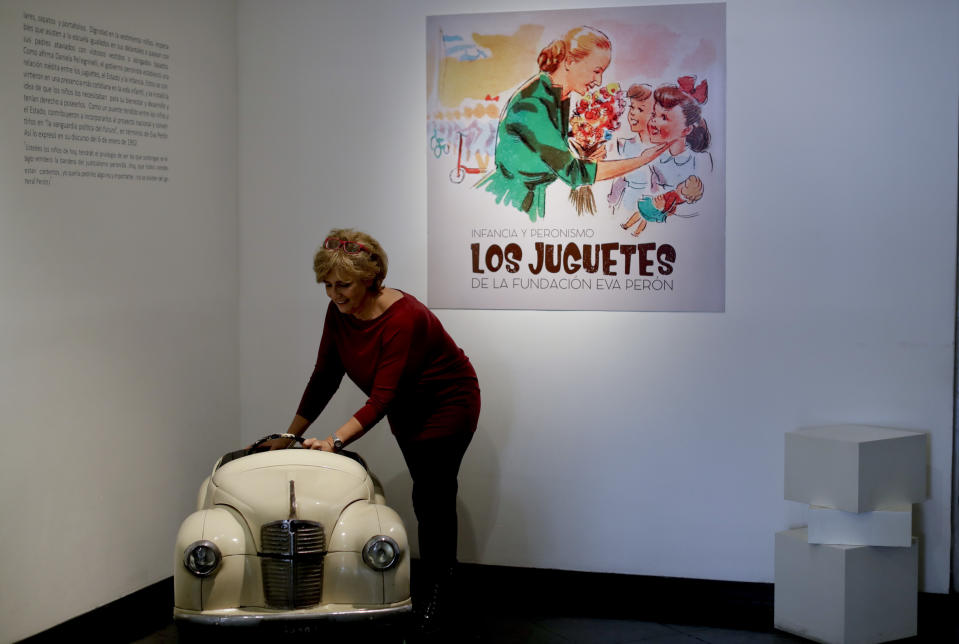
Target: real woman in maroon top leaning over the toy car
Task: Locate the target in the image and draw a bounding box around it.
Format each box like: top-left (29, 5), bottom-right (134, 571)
top-left (271, 229), bottom-right (480, 628)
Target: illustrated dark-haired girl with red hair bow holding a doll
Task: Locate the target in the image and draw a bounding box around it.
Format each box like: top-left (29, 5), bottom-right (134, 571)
top-left (621, 76), bottom-right (713, 236)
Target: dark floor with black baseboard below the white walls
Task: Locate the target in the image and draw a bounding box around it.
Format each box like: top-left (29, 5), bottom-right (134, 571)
top-left (23, 561), bottom-right (959, 644)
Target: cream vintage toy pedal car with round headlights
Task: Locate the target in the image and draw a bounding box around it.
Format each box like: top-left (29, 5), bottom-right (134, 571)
top-left (173, 434), bottom-right (412, 627)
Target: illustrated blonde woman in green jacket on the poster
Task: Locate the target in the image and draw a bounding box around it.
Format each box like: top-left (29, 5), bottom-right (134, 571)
top-left (477, 27), bottom-right (666, 221)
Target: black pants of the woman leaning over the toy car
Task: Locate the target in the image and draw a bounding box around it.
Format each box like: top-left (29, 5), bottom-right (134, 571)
top-left (400, 433), bottom-right (473, 571)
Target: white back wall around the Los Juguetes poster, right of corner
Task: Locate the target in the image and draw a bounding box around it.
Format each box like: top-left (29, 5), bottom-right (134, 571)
top-left (238, 0), bottom-right (959, 592)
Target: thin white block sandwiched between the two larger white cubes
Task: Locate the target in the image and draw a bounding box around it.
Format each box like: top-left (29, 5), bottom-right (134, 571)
top-left (809, 505), bottom-right (912, 548)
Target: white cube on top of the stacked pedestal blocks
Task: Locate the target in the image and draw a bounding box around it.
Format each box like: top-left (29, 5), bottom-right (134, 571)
top-left (785, 425), bottom-right (928, 512)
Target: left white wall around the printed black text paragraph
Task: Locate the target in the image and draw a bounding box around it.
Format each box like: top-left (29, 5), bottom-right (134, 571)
top-left (0, 0), bottom-right (239, 641)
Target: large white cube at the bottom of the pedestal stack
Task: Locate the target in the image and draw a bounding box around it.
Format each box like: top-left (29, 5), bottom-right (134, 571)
top-left (774, 528), bottom-right (919, 644)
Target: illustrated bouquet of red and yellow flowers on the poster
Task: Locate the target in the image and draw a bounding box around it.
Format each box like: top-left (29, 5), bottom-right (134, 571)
top-left (569, 83), bottom-right (626, 215)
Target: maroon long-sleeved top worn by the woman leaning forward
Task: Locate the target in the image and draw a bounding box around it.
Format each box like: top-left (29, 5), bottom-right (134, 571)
top-left (297, 293), bottom-right (479, 440)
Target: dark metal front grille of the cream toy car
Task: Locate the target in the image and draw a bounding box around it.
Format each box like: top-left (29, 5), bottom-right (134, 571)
top-left (260, 519), bottom-right (326, 609)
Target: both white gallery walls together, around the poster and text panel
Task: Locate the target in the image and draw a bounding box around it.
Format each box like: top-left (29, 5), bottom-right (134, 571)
top-left (0, 0), bottom-right (959, 641)
